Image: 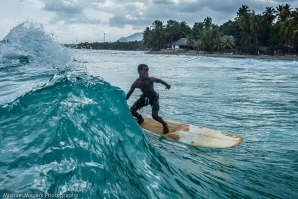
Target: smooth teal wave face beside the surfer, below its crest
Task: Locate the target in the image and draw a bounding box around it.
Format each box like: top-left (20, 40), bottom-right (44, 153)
top-left (0, 76), bottom-right (196, 198)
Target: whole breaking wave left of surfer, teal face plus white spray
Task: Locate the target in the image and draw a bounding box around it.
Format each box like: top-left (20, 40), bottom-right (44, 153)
top-left (0, 22), bottom-right (199, 198)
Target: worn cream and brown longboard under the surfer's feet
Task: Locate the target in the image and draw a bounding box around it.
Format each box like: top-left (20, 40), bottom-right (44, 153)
top-left (140, 118), bottom-right (243, 148)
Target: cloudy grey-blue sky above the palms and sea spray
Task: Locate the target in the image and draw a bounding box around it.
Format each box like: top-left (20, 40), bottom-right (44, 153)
top-left (0, 0), bottom-right (298, 43)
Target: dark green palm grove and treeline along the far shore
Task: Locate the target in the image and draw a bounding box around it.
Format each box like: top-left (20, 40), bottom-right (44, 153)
top-left (68, 4), bottom-right (298, 55)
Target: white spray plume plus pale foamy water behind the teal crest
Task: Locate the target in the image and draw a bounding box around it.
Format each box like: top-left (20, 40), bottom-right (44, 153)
top-left (0, 21), bottom-right (74, 104)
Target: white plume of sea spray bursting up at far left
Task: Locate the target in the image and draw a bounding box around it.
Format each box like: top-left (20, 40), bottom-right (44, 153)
top-left (0, 21), bottom-right (70, 70)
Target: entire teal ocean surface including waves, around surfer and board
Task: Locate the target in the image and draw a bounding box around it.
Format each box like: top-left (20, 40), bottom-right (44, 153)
top-left (0, 22), bottom-right (298, 199)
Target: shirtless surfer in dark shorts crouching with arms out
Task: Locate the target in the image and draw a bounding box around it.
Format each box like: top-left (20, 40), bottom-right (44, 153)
top-left (126, 64), bottom-right (171, 133)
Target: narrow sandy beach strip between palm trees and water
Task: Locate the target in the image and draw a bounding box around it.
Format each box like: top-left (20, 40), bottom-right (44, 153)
top-left (146, 51), bottom-right (298, 61)
